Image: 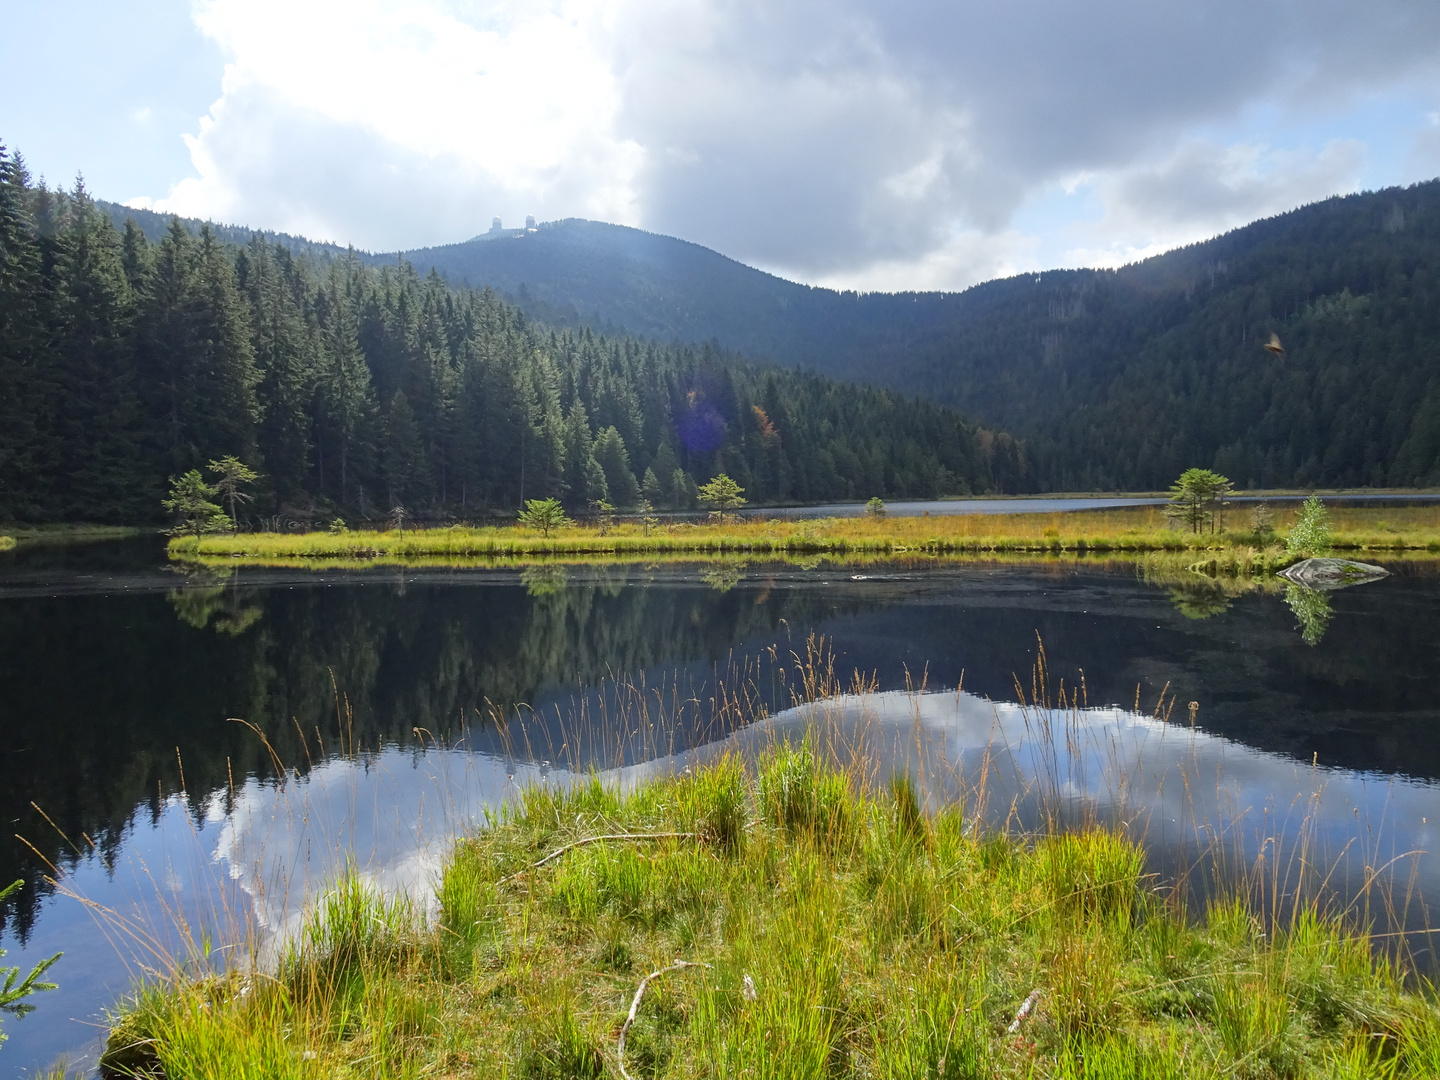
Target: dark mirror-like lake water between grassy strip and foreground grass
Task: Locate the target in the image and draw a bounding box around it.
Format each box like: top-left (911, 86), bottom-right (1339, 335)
top-left (0, 540), bottom-right (1440, 1070)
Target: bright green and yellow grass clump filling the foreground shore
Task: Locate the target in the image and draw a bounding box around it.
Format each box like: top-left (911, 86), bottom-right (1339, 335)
top-left (105, 746), bottom-right (1440, 1080)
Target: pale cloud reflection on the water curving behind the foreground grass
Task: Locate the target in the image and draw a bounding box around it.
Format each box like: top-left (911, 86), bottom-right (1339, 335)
top-left (197, 691), bottom-right (1440, 979)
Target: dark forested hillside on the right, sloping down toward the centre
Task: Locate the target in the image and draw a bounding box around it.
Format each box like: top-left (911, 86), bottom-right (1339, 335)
top-left (887, 181), bottom-right (1440, 490)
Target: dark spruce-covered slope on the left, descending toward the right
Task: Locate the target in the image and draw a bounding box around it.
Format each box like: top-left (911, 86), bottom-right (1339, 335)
top-left (0, 146), bottom-right (1017, 521)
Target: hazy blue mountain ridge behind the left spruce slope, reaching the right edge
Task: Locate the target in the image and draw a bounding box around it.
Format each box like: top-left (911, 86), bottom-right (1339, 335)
top-left (106, 181), bottom-right (1440, 490)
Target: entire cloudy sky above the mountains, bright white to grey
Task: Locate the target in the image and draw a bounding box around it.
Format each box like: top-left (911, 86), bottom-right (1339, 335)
top-left (0, 0), bottom-right (1440, 291)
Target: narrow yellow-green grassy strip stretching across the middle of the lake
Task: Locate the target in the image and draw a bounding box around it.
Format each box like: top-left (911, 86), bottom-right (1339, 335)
top-left (170, 507), bottom-right (1440, 572)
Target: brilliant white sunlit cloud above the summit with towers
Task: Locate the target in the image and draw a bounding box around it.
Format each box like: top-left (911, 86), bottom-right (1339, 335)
top-left (160, 0), bottom-right (638, 249)
